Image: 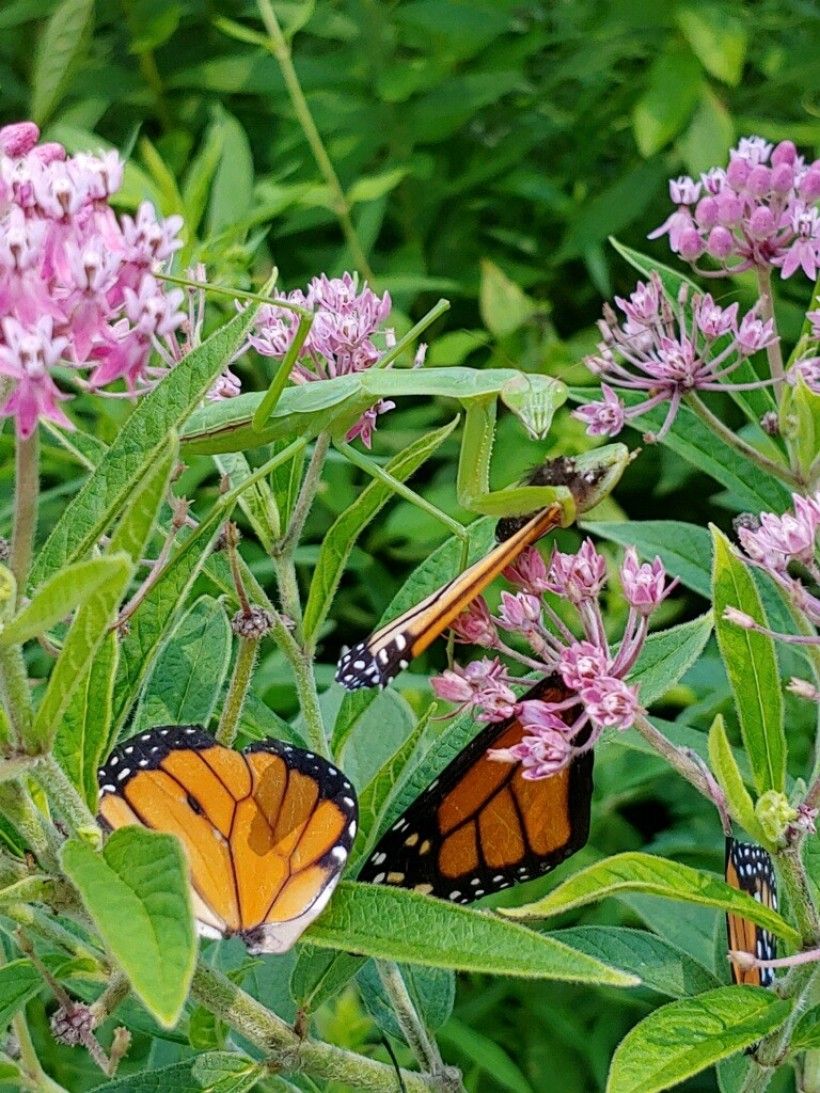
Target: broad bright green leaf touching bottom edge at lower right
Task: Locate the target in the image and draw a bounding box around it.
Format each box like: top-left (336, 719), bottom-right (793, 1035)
top-left (607, 987), bottom-right (792, 1093)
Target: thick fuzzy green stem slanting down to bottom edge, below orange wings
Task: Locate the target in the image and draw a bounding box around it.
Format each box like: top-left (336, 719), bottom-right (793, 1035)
top-left (191, 961), bottom-right (441, 1093)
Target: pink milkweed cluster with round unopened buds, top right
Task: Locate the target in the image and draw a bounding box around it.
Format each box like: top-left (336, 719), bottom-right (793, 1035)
top-left (649, 137), bottom-right (820, 281)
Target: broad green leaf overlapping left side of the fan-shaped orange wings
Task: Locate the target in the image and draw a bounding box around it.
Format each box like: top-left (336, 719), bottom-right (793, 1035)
top-left (62, 827), bottom-right (197, 1029)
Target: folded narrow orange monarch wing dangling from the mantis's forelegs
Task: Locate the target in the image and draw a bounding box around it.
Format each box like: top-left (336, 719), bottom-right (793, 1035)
top-left (336, 505), bottom-right (563, 691)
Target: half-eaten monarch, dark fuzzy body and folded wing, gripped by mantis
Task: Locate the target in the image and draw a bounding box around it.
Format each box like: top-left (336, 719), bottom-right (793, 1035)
top-left (336, 456), bottom-right (606, 691)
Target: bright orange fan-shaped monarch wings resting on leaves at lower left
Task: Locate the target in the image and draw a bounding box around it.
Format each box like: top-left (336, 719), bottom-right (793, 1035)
top-left (98, 725), bottom-right (358, 953)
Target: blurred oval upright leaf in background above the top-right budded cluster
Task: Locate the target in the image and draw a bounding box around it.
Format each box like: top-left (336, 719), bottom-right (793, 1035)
top-left (632, 43), bottom-right (702, 158)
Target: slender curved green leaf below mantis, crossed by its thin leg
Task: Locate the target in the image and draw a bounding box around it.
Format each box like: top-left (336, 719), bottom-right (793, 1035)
top-left (302, 418), bottom-right (458, 640)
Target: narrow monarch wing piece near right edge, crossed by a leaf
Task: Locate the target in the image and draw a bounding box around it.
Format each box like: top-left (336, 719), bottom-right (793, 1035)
top-left (726, 837), bottom-right (777, 987)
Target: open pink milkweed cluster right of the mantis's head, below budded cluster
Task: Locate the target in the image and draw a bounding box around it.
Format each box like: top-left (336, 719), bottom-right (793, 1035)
top-left (573, 273), bottom-right (777, 440)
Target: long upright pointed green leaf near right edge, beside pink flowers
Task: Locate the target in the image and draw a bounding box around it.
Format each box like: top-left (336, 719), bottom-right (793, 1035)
top-left (712, 527), bottom-right (786, 794)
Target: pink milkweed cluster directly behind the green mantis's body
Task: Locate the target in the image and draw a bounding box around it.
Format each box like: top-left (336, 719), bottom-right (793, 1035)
top-left (249, 273), bottom-right (400, 447)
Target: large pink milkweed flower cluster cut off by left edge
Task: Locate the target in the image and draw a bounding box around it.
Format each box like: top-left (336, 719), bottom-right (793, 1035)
top-left (0, 121), bottom-right (186, 438)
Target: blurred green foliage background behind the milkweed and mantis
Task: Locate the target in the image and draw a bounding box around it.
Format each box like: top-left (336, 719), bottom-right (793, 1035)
top-left (0, 0), bottom-right (820, 1093)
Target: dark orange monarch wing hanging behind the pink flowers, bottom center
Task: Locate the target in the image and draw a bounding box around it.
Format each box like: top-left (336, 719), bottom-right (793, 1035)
top-left (359, 675), bottom-right (593, 903)
